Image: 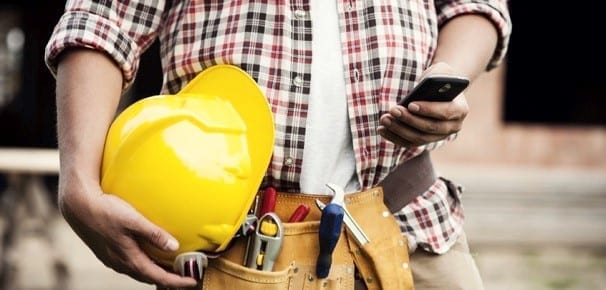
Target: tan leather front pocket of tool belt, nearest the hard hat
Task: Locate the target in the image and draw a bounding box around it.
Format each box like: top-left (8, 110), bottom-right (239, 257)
top-left (202, 221), bottom-right (355, 290)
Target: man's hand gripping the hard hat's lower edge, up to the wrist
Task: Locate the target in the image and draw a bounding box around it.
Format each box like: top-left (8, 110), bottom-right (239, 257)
top-left (59, 179), bottom-right (196, 288)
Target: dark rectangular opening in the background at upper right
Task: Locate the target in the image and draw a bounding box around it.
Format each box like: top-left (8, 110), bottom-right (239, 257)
top-left (504, 1), bottom-right (606, 125)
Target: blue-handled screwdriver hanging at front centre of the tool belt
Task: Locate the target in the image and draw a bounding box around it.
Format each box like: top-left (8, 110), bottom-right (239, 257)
top-left (316, 186), bottom-right (344, 278)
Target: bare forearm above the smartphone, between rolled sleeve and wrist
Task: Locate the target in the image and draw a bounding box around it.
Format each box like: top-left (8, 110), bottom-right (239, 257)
top-left (433, 14), bottom-right (498, 80)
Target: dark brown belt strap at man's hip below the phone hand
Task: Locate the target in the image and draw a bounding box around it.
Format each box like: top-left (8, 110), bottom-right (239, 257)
top-left (379, 151), bottom-right (437, 213)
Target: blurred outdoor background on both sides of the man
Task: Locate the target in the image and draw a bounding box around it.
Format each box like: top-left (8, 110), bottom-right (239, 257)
top-left (0, 0), bottom-right (606, 290)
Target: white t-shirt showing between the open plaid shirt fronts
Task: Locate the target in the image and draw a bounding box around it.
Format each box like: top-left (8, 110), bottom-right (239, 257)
top-left (301, 0), bottom-right (360, 194)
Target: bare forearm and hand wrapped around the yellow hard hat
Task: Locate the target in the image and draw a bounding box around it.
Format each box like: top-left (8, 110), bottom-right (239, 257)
top-left (57, 49), bottom-right (196, 288)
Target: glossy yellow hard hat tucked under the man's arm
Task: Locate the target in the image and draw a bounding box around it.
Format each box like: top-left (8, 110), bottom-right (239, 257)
top-left (101, 65), bottom-right (274, 265)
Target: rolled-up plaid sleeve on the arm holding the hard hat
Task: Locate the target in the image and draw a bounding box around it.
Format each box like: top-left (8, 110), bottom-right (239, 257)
top-left (44, 1), bottom-right (164, 89)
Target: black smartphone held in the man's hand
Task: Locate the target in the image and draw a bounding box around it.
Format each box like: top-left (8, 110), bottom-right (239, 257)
top-left (399, 75), bottom-right (469, 107)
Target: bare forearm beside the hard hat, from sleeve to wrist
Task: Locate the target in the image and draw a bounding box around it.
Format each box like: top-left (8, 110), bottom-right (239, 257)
top-left (56, 49), bottom-right (122, 194)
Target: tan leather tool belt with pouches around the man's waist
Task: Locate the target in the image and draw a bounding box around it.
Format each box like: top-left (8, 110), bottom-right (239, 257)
top-left (202, 188), bottom-right (412, 290)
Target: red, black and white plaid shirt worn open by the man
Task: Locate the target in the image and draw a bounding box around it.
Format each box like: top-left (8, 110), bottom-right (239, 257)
top-left (45, 0), bottom-right (510, 253)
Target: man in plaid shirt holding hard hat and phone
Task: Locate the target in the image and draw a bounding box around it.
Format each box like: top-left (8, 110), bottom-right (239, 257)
top-left (46, 0), bottom-right (511, 289)
